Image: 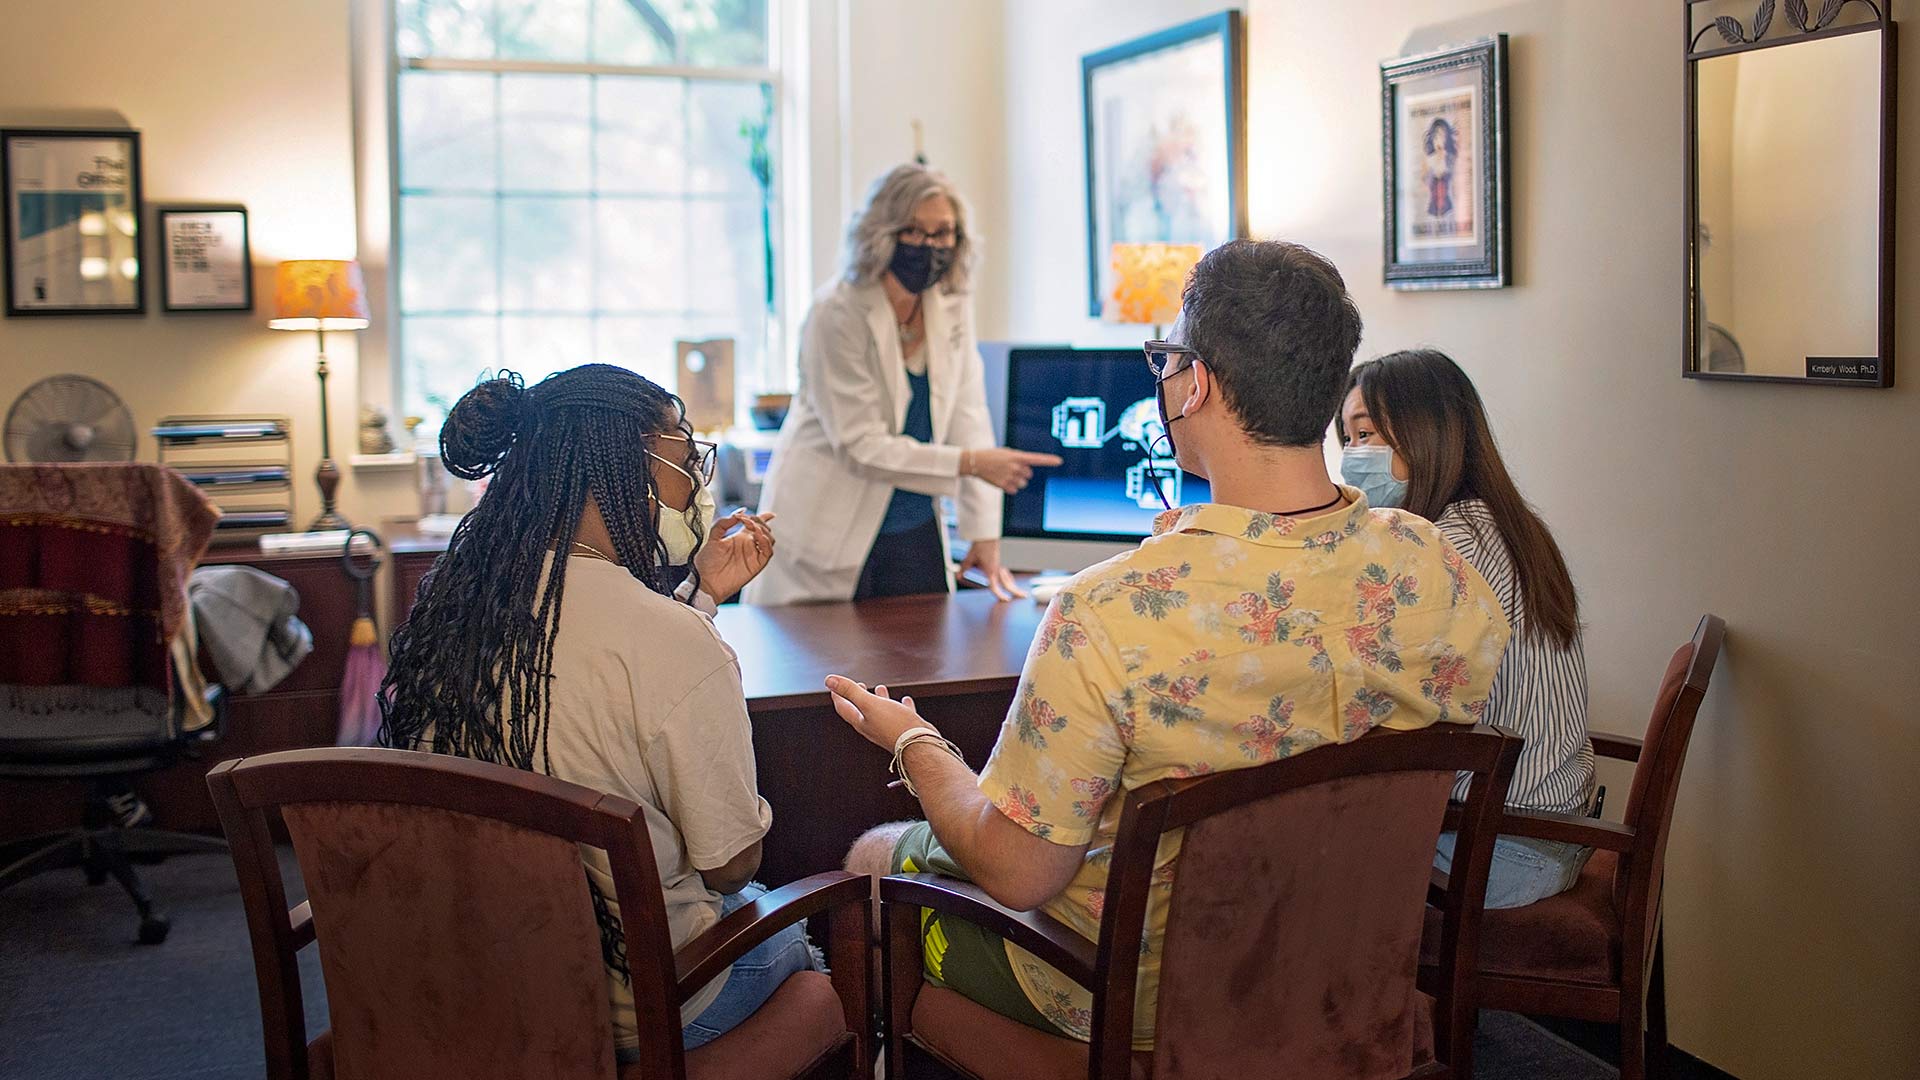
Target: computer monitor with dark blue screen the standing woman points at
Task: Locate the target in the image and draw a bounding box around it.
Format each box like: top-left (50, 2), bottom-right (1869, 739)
top-left (1004, 348), bottom-right (1212, 552)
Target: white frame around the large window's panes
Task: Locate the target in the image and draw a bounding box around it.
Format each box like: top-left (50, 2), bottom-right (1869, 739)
top-left (384, 0), bottom-right (808, 438)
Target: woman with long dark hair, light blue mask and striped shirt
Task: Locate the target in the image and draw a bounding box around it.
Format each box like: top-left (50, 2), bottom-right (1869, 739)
top-left (1338, 350), bottom-right (1594, 907)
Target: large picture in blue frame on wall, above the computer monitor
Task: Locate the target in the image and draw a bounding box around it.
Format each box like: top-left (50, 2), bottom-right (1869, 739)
top-left (1081, 12), bottom-right (1246, 315)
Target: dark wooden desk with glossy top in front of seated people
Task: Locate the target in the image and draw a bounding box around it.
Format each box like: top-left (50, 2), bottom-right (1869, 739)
top-left (718, 590), bottom-right (1044, 886)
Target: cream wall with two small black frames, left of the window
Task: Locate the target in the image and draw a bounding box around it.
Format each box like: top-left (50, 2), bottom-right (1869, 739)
top-left (0, 0), bottom-right (424, 523)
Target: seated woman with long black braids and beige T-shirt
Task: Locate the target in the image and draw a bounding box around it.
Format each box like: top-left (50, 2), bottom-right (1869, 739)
top-left (380, 363), bottom-right (812, 1059)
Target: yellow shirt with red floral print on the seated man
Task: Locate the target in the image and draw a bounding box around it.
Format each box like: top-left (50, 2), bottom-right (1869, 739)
top-left (979, 488), bottom-right (1509, 1049)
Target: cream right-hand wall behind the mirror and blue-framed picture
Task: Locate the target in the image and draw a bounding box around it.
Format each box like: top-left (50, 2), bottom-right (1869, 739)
top-left (1004, 0), bottom-right (1920, 1080)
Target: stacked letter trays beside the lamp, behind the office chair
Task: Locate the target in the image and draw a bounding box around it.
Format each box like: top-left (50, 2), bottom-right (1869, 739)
top-left (152, 415), bottom-right (294, 544)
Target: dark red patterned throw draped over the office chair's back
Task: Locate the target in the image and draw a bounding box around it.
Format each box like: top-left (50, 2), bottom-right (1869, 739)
top-left (0, 463), bottom-right (219, 688)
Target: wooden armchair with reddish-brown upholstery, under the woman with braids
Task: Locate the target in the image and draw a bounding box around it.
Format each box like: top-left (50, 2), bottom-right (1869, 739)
top-left (207, 749), bottom-right (874, 1080)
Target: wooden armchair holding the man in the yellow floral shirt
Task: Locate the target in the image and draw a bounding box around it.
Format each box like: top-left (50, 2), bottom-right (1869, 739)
top-left (879, 724), bottom-right (1521, 1080)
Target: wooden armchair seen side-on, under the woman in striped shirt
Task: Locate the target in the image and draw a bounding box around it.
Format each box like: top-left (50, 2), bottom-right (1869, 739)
top-left (1423, 615), bottom-right (1726, 1080)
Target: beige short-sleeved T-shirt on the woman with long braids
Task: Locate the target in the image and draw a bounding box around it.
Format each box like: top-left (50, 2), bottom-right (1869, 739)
top-left (536, 557), bottom-right (774, 1047)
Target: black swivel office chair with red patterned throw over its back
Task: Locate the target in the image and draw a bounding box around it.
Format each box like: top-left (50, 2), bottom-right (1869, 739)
top-left (0, 463), bottom-right (225, 944)
